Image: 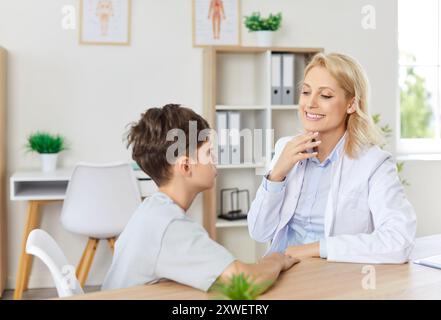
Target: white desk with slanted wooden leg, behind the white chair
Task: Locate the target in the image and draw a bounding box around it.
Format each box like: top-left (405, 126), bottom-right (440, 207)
top-left (10, 168), bottom-right (157, 299)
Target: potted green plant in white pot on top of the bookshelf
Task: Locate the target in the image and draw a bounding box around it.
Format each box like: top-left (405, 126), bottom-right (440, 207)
top-left (245, 12), bottom-right (282, 47)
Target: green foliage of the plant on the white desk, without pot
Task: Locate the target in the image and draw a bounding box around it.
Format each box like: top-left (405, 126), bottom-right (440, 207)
top-left (26, 132), bottom-right (67, 153)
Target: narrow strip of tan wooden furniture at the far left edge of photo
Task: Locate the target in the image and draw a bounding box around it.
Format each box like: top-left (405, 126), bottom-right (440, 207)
top-left (0, 47), bottom-right (7, 297)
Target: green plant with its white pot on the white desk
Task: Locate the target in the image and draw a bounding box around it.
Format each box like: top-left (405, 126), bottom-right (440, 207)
top-left (26, 132), bottom-right (66, 172)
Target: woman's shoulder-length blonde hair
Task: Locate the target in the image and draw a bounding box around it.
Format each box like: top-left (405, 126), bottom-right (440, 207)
top-left (304, 53), bottom-right (384, 158)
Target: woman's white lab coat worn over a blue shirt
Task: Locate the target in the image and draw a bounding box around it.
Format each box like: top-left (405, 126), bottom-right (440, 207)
top-left (248, 137), bottom-right (416, 263)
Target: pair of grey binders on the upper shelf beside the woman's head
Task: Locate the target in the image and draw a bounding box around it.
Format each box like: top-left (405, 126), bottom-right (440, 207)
top-left (271, 53), bottom-right (296, 105)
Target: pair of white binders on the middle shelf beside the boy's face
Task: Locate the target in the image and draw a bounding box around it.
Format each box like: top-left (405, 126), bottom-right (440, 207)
top-left (216, 111), bottom-right (242, 164)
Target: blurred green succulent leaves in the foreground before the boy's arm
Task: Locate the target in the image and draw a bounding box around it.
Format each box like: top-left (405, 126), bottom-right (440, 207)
top-left (210, 273), bottom-right (272, 300)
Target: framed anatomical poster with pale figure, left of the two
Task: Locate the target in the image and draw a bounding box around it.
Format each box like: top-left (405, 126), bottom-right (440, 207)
top-left (78, 0), bottom-right (132, 46)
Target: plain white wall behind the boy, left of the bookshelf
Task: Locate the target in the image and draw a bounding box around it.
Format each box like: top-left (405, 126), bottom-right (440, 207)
top-left (0, 0), bottom-right (206, 287)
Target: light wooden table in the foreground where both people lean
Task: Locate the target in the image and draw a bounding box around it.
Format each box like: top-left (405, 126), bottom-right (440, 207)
top-left (63, 235), bottom-right (441, 300)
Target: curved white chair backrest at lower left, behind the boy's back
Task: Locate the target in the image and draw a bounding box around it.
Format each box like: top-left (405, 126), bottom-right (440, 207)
top-left (26, 229), bottom-right (84, 298)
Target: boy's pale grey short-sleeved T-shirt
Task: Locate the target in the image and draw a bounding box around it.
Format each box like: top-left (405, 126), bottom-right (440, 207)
top-left (102, 192), bottom-right (235, 291)
